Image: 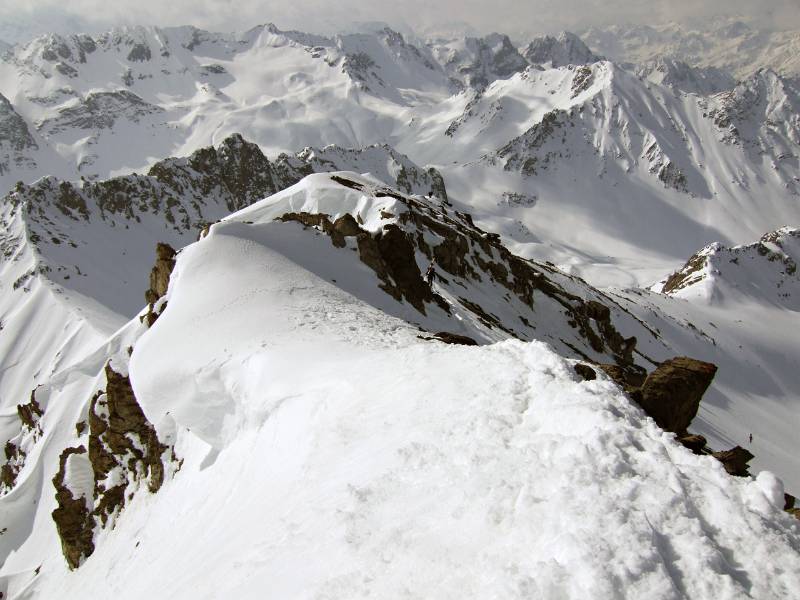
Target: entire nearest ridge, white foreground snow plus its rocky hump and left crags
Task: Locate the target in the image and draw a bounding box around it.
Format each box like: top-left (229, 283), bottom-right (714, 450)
top-left (0, 172), bottom-right (800, 598)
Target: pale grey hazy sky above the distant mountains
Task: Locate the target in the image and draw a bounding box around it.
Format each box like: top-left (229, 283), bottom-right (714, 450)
top-left (0, 0), bottom-right (800, 41)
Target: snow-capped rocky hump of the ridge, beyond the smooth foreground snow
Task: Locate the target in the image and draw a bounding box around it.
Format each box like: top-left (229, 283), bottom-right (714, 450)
top-left (210, 173), bottom-right (652, 369)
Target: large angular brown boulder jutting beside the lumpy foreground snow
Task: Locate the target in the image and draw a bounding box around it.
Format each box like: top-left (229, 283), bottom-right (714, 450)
top-left (636, 356), bottom-right (717, 434)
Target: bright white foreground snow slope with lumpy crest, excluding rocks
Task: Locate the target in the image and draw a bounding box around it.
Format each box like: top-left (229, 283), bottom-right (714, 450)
top-left (0, 176), bottom-right (800, 598)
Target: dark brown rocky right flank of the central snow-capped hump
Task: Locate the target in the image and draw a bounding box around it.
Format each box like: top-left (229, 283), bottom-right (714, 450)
top-left (277, 174), bottom-right (644, 366)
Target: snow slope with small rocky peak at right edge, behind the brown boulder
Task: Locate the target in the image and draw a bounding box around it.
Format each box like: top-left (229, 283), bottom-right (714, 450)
top-left (600, 228), bottom-right (800, 489)
